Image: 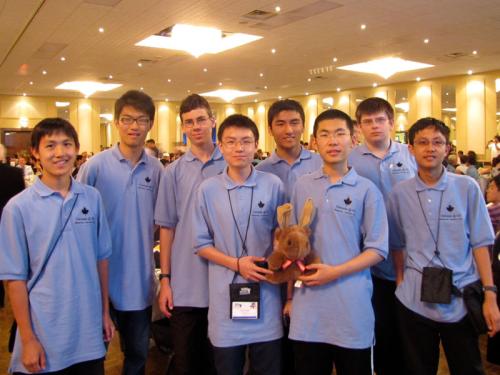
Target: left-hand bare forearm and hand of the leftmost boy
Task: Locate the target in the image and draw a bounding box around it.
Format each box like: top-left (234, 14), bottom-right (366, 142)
top-left (7, 280), bottom-right (46, 372)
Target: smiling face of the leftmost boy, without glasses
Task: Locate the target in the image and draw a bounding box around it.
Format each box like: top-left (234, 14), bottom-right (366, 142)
top-left (31, 132), bottom-right (78, 181)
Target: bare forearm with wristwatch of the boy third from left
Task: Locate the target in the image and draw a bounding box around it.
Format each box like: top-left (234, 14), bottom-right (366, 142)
top-left (158, 227), bottom-right (175, 318)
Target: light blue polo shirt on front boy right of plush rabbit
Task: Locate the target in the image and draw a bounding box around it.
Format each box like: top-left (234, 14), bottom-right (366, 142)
top-left (289, 168), bottom-right (388, 349)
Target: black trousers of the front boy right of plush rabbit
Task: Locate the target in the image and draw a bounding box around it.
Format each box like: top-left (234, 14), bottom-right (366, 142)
top-left (294, 341), bottom-right (373, 375)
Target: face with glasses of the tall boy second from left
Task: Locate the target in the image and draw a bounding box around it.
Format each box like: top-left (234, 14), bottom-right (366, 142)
top-left (115, 105), bottom-right (153, 149)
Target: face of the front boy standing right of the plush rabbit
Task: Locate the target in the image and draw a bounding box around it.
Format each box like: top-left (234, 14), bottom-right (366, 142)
top-left (315, 118), bottom-right (354, 165)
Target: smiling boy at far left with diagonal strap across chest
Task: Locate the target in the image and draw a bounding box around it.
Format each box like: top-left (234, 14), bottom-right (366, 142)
top-left (0, 118), bottom-right (114, 375)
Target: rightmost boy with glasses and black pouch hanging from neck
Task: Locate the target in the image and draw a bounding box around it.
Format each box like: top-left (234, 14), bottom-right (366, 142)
top-left (388, 117), bottom-right (500, 375)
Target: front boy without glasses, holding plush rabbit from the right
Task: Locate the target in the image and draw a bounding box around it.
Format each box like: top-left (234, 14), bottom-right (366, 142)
top-left (289, 109), bottom-right (388, 375)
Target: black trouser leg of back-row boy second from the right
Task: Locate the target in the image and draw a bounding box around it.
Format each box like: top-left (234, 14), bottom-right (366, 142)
top-left (372, 276), bottom-right (406, 375)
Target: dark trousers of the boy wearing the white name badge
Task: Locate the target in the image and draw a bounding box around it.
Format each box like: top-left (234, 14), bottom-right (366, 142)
top-left (213, 339), bottom-right (282, 375)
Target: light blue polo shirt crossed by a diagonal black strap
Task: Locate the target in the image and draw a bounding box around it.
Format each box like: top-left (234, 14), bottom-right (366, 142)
top-left (0, 179), bottom-right (111, 373)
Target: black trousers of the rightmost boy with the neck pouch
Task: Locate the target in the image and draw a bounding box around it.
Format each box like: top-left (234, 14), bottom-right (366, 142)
top-left (397, 301), bottom-right (484, 375)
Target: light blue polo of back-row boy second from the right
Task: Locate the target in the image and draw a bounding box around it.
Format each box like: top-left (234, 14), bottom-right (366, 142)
top-left (349, 141), bottom-right (417, 281)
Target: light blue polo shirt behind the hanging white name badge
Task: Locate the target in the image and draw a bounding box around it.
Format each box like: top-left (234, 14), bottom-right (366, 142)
top-left (193, 169), bottom-right (284, 347)
